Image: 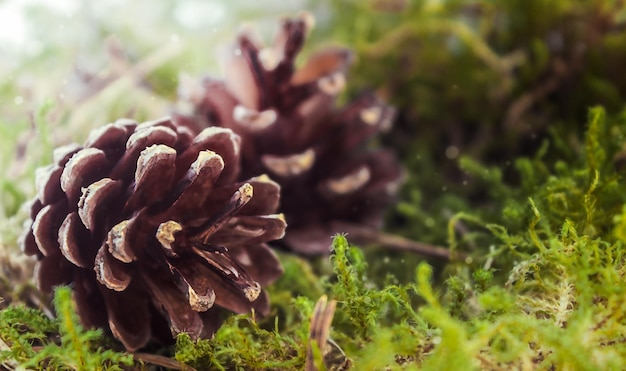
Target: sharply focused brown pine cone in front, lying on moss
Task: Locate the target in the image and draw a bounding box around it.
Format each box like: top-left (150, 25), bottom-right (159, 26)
top-left (22, 119), bottom-right (285, 351)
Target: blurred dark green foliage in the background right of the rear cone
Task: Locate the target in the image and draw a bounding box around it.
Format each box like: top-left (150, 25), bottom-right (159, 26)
top-left (316, 0), bottom-right (626, 250)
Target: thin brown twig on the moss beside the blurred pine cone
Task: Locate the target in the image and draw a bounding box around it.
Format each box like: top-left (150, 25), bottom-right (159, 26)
top-left (337, 223), bottom-right (463, 260)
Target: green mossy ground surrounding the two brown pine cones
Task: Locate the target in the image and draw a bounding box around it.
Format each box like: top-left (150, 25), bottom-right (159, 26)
top-left (0, 0), bottom-right (626, 370)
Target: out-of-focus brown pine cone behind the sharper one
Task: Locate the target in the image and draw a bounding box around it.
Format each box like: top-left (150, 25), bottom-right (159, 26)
top-left (174, 17), bottom-right (402, 254)
